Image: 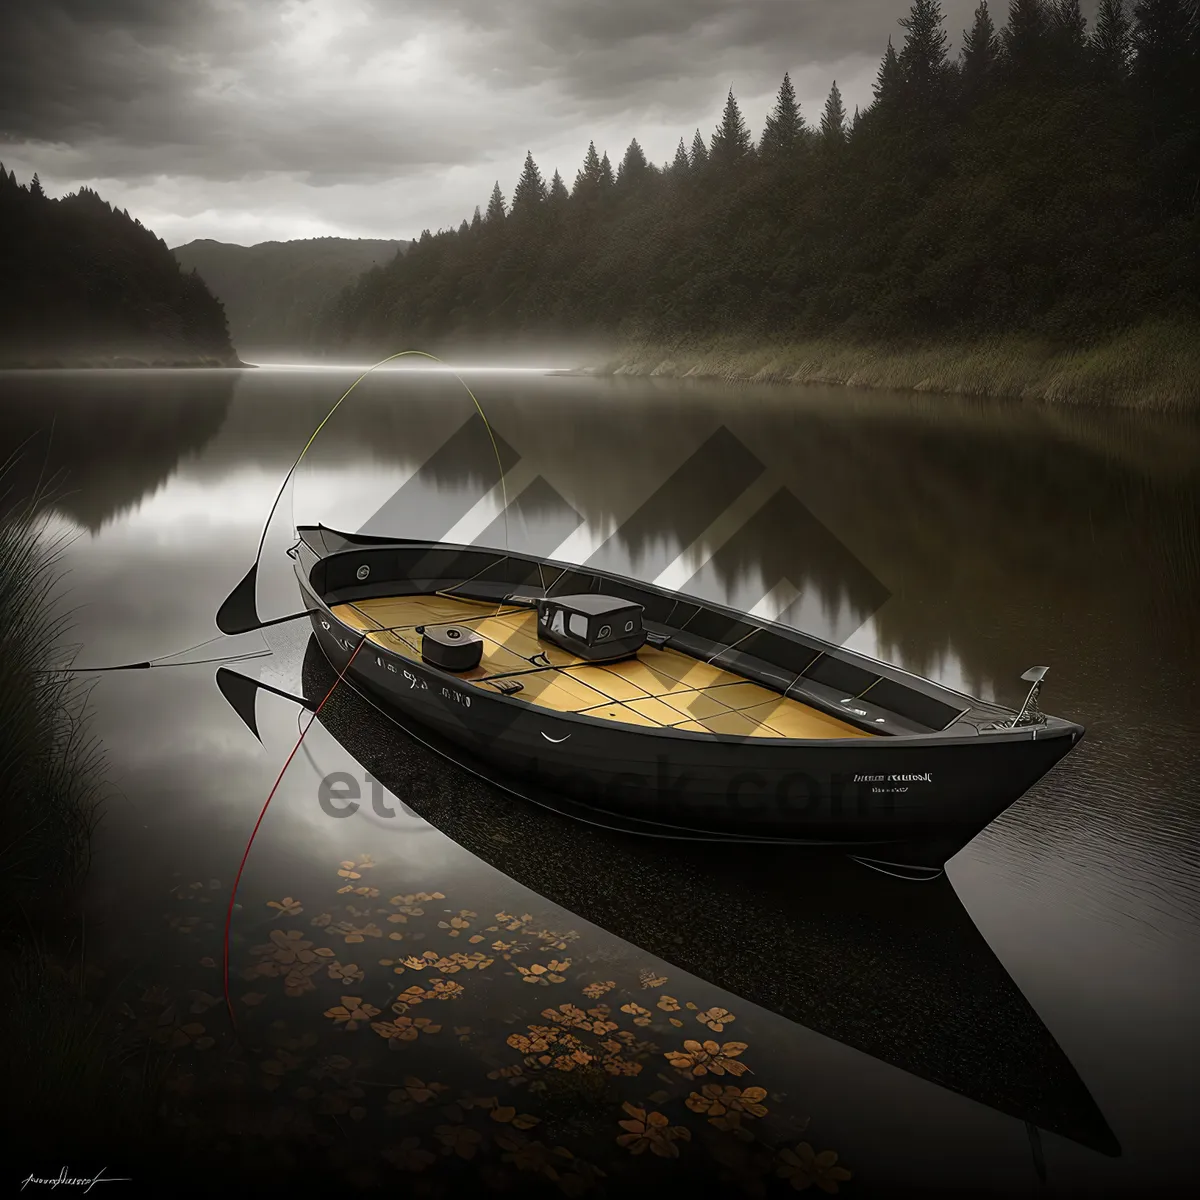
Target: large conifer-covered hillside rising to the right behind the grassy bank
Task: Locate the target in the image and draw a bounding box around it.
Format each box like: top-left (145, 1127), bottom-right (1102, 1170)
top-left (318, 0), bottom-right (1200, 352)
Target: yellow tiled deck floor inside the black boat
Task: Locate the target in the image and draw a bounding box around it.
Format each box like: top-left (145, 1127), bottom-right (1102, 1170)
top-left (332, 594), bottom-right (875, 739)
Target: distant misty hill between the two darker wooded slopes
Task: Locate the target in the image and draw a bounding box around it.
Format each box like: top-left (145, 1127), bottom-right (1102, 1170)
top-left (173, 238), bottom-right (412, 353)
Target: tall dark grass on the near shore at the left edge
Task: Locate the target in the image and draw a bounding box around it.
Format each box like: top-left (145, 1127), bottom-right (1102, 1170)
top-left (0, 458), bottom-right (163, 1154)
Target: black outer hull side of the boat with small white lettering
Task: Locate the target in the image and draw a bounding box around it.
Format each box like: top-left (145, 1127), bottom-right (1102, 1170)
top-left (296, 542), bottom-right (1082, 866)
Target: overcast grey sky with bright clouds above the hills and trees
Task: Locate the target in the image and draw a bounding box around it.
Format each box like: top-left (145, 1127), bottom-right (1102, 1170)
top-left (0, 0), bottom-right (1075, 246)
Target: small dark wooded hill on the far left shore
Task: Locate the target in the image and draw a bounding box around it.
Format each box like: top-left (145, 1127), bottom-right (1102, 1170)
top-left (0, 166), bottom-right (238, 366)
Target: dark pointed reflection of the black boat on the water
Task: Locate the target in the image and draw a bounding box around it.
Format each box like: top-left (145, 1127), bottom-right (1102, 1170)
top-left (217, 638), bottom-right (1121, 1157)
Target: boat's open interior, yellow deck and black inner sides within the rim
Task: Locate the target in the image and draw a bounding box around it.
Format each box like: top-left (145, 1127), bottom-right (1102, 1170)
top-left (300, 527), bottom-right (1013, 740)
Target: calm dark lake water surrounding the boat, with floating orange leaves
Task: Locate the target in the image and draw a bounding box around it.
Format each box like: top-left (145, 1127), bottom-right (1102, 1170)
top-left (0, 368), bottom-right (1200, 1195)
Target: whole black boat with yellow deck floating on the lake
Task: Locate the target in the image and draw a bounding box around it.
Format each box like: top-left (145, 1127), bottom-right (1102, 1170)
top-left (289, 526), bottom-right (1084, 875)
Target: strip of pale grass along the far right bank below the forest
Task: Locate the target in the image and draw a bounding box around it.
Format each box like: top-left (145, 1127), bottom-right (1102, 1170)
top-left (596, 322), bottom-right (1200, 412)
